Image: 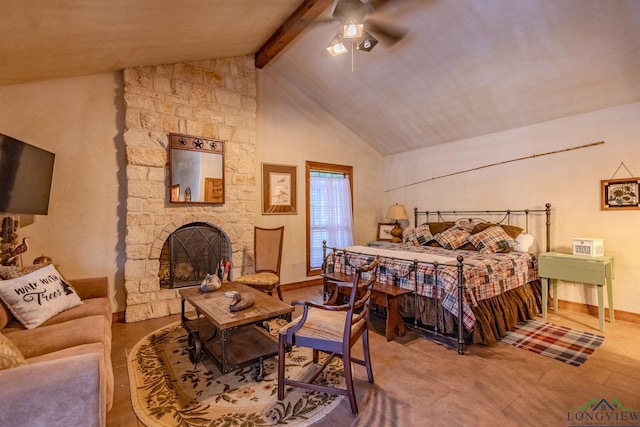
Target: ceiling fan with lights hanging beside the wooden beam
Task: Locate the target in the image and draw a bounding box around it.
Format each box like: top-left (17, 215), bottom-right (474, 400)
top-left (327, 0), bottom-right (406, 56)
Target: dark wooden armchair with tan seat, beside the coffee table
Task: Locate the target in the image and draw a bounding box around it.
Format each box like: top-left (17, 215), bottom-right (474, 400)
top-left (278, 257), bottom-right (380, 415)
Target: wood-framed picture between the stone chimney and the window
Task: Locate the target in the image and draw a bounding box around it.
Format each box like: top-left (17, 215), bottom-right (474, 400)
top-left (262, 163), bottom-right (297, 215)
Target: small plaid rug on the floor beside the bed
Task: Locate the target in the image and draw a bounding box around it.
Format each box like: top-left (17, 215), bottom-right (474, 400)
top-left (501, 320), bottom-right (604, 366)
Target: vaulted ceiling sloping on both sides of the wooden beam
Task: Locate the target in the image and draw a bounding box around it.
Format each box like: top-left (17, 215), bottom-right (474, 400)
top-left (0, 0), bottom-right (640, 155)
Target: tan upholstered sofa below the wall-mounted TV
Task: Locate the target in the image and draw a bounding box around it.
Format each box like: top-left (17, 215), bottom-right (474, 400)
top-left (0, 267), bottom-right (114, 427)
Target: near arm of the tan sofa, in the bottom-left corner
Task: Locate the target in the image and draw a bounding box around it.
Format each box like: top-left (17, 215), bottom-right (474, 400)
top-left (0, 353), bottom-right (106, 427)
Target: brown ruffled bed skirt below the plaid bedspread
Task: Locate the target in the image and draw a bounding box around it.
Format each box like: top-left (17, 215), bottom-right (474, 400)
top-left (399, 280), bottom-right (542, 345)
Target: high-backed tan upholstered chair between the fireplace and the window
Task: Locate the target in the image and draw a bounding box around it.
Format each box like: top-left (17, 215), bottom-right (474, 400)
top-left (233, 225), bottom-right (284, 300)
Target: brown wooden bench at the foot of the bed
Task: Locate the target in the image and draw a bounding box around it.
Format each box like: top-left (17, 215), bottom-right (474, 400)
top-left (321, 273), bottom-right (413, 341)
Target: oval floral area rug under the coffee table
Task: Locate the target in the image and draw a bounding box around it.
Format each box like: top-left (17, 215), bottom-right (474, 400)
top-left (128, 322), bottom-right (345, 427)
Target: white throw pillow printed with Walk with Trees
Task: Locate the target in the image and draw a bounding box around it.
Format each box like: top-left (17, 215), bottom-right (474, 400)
top-left (0, 265), bottom-right (82, 329)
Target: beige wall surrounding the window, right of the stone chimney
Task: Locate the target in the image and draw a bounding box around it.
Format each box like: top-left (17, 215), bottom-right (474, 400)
top-left (256, 67), bottom-right (383, 283)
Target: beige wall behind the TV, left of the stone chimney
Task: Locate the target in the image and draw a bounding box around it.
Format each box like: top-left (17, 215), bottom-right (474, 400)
top-left (0, 73), bottom-right (124, 310)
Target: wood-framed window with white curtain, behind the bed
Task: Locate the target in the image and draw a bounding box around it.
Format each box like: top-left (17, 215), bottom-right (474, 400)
top-left (306, 162), bottom-right (353, 276)
